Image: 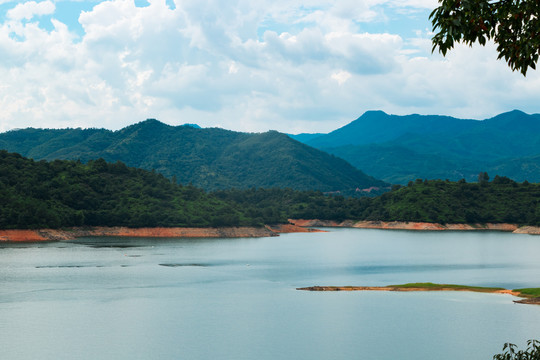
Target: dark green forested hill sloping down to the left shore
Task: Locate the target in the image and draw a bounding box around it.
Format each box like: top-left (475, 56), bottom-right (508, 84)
top-left (0, 151), bottom-right (253, 229)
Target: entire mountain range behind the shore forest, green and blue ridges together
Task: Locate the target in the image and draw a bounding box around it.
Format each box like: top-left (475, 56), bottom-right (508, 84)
top-left (5, 110), bottom-right (540, 190)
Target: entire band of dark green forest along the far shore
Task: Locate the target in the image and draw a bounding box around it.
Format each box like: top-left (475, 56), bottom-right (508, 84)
top-left (0, 151), bottom-right (540, 229)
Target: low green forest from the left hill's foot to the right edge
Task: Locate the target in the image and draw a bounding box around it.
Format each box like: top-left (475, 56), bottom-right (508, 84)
top-left (216, 176), bottom-right (540, 226)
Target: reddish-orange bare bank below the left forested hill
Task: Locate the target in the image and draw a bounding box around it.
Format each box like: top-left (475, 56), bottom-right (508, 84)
top-left (0, 224), bottom-right (323, 242)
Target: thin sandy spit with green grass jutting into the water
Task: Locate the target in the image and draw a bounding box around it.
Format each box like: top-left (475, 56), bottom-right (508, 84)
top-left (296, 285), bottom-right (540, 305)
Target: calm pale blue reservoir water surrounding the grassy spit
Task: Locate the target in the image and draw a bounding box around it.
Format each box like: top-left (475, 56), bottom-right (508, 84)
top-left (0, 229), bottom-right (540, 360)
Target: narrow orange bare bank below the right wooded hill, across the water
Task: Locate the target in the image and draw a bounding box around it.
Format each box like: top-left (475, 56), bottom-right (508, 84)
top-left (289, 219), bottom-right (540, 235)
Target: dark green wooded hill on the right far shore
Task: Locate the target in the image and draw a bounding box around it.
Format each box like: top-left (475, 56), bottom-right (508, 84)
top-left (362, 176), bottom-right (540, 226)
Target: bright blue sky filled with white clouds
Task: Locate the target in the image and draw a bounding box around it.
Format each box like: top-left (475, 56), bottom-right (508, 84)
top-left (0, 0), bottom-right (540, 133)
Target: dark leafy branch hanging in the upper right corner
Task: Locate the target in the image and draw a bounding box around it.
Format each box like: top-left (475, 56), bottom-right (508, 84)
top-left (429, 0), bottom-right (540, 76)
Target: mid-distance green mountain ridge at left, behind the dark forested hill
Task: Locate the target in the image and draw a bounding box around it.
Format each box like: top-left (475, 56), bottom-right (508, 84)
top-left (0, 120), bottom-right (387, 192)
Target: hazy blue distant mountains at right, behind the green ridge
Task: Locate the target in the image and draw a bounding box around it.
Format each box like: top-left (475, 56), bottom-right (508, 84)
top-left (291, 110), bottom-right (540, 184)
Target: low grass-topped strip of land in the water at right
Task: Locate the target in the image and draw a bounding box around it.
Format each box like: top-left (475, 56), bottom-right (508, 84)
top-left (296, 282), bottom-right (540, 305)
